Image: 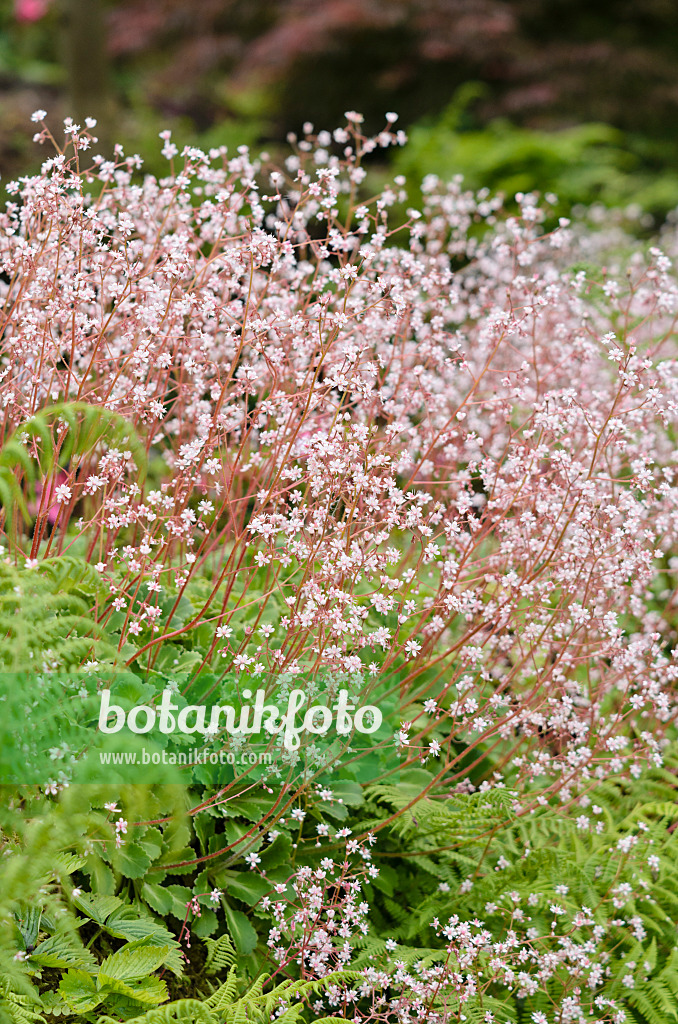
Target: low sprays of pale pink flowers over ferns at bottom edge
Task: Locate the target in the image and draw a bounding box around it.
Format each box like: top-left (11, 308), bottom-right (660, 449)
top-left (245, 829), bottom-right (656, 1024)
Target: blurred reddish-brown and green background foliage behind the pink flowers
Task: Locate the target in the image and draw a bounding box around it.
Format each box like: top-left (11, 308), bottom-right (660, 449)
top-left (0, 0), bottom-right (678, 225)
